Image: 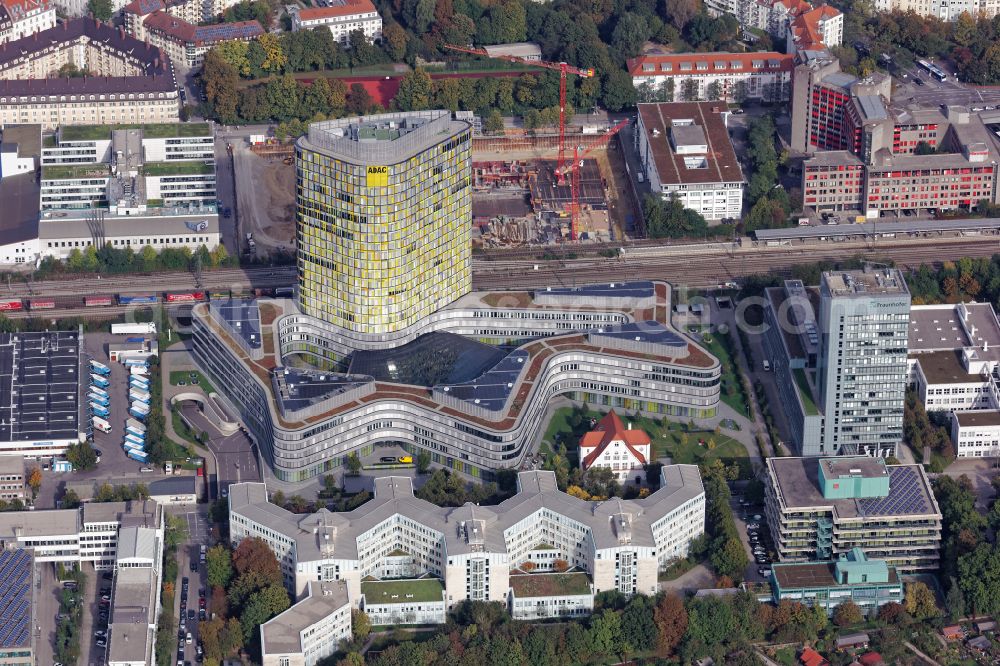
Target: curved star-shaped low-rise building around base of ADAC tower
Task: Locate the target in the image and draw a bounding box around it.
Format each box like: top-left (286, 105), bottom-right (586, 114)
top-left (193, 282), bottom-right (721, 482)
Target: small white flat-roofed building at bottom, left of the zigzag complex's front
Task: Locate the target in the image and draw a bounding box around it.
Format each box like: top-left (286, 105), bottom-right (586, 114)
top-left (260, 580), bottom-right (351, 666)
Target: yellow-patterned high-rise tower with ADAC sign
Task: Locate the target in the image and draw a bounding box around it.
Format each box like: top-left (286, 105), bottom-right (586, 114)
top-left (296, 111), bottom-right (472, 337)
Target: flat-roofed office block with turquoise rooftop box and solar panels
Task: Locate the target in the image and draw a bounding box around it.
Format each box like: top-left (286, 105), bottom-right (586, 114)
top-left (765, 456), bottom-right (941, 574)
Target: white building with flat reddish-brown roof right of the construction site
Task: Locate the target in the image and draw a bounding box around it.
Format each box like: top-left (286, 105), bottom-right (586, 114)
top-left (635, 102), bottom-right (745, 220)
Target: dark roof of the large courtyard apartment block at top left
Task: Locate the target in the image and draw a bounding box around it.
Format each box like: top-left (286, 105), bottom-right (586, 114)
top-left (0, 18), bottom-right (177, 96)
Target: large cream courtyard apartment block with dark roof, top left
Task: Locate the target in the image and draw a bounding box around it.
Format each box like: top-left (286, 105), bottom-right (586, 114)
top-left (0, 19), bottom-right (180, 130)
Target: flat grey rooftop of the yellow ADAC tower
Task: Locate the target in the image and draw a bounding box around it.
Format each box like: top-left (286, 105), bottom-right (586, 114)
top-left (299, 111), bottom-right (471, 164)
